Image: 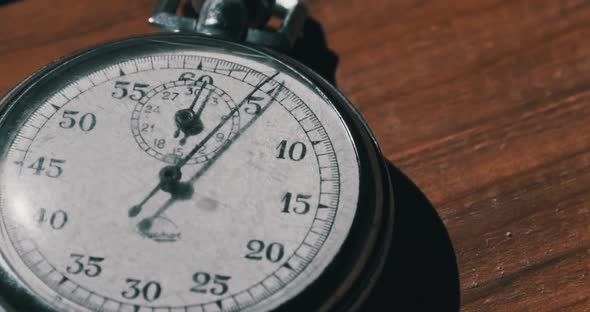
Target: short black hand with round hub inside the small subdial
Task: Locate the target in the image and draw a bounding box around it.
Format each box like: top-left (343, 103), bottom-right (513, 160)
top-left (174, 83), bottom-right (213, 145)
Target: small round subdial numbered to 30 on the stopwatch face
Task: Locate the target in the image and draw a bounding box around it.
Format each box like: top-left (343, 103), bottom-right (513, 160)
top-left (131, 76), bottom-right (240, 164)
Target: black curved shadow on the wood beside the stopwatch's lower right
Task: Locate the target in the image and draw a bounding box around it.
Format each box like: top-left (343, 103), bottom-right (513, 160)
top-left (362, 165), bottom-right (460, 312)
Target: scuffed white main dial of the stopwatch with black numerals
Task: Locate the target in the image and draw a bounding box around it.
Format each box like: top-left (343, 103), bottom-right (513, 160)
top-left (0, 42), bottom-right (359, 312)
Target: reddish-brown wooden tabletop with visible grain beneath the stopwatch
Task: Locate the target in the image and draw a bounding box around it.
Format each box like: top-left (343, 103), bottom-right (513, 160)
top-left (0, 0), bottom-right (590, 311)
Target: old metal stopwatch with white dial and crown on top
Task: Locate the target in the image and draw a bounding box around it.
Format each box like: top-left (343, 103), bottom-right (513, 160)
top-left (0, 0), bottom-right (393, 312)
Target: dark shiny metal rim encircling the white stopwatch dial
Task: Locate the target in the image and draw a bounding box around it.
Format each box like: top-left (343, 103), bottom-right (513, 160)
top-left (0, 33), bottom-right (393, 312)
